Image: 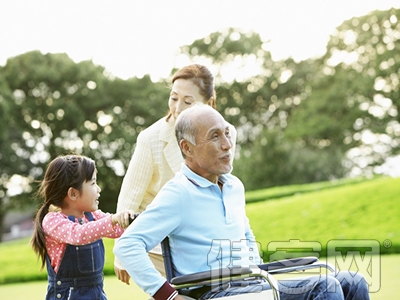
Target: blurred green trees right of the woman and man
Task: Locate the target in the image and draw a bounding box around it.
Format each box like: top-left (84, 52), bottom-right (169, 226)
top-left (177, 9), bottom-right (400, 188)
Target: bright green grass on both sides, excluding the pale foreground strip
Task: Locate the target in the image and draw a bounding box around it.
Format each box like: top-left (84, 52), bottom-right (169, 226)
top-left (0, 178), bottom-right (400, 299)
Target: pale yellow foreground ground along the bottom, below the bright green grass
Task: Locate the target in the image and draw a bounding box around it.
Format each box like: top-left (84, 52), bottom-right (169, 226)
top-left (0, 254), bottom-right (400, 300)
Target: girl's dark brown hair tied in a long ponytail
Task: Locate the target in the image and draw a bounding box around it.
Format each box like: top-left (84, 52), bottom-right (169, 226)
top-left (31, 155), bottom-right (96, 269)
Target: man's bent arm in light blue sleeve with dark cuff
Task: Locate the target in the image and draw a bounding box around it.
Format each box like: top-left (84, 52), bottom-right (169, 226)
top-left (114, 184), bottom-right (181, 299)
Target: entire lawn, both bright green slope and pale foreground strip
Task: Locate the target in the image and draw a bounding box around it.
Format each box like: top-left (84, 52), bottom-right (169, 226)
top-left (0, 178), bottom-right (400, 300)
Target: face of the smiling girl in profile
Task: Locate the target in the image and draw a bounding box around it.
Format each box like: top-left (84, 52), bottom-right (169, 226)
top-left (76, 171), bottom-right (101, 212)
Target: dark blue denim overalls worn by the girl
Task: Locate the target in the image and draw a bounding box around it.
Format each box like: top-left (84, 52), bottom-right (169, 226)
top-left (46, 213), bottom-right (107, 300)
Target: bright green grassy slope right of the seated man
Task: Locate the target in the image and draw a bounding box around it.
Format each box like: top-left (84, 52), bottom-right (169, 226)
top-left (247, 178), bottom-right (400, 254)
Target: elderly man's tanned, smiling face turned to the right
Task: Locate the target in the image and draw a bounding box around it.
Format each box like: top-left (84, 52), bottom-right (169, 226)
top-left (189, 112), bottom-right (232, 183)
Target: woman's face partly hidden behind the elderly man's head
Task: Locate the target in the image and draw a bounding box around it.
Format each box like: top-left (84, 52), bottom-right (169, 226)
top-left (168, 79), bottom-right (207, 121)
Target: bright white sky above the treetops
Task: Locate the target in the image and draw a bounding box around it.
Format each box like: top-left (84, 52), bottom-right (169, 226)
top-left (0, 0), bottom-right (400, 80)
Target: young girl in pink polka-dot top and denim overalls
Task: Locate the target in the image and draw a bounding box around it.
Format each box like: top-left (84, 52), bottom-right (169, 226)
top-left (31, 155), bottom-right (134, 300)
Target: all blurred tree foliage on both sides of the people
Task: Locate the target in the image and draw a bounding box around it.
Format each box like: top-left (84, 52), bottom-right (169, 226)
top-left (0, 9), bottom-right (400, 240)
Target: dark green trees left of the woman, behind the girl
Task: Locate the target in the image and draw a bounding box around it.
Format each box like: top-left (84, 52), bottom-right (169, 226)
top-left (0, 51), bottom-right (168, 239)
